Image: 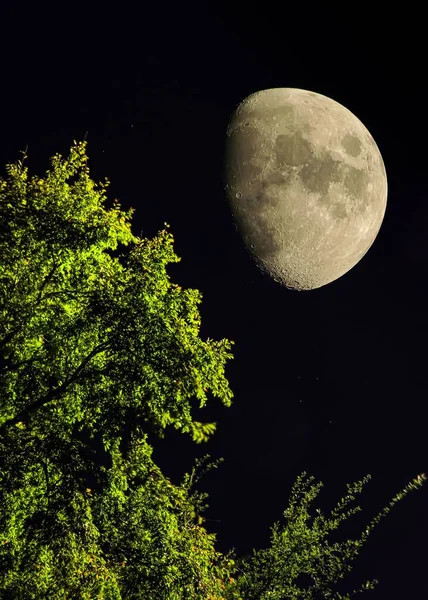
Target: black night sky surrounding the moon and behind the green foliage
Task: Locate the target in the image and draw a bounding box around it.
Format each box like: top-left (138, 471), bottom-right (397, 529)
top-left (0, 2), bottom-right (428, 600)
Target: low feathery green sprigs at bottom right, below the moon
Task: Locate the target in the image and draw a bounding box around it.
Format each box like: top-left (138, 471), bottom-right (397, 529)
top-left (222, 472), bottom-right (426, 600)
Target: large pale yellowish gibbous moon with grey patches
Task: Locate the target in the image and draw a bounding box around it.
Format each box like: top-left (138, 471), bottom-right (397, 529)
top-left (223, 88), bottom-right (387, 291)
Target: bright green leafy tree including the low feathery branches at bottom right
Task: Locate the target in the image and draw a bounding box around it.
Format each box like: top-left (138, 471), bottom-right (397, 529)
top-left (0, 142), bottom-right (425, 600)
